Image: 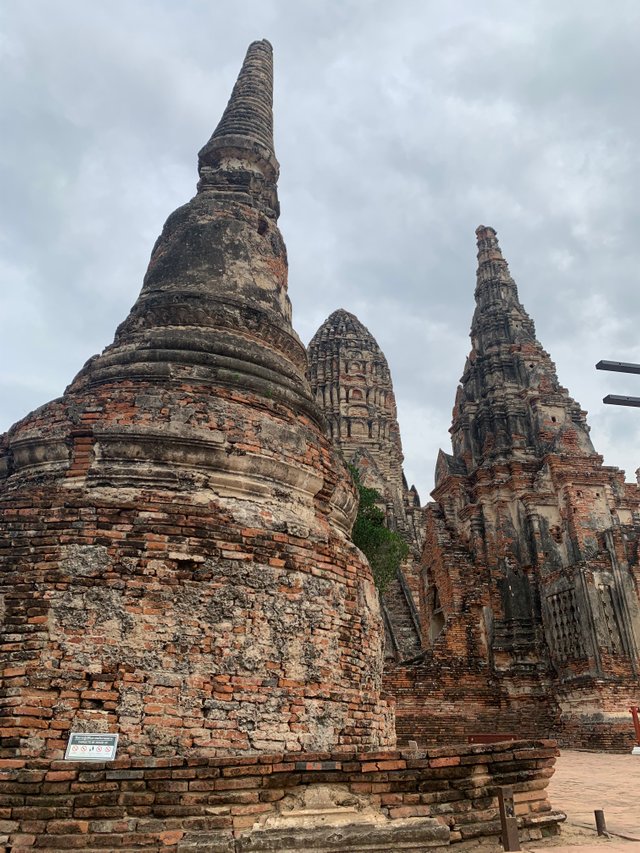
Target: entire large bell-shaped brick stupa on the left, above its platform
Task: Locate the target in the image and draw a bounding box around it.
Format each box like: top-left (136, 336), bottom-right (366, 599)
top-left (0, 41), bottom-right (394, 758)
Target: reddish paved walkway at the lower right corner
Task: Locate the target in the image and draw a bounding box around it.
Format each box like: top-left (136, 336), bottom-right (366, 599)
top-left (540, 750), bottom-right (640, 853)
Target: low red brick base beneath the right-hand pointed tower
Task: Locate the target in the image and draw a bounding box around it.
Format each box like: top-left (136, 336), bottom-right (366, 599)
top-left (383, 643), bottom-right (640, 752)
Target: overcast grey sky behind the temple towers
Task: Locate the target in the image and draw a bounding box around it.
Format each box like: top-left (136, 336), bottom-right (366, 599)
top-left (0, 0), bottom-right (640, 501)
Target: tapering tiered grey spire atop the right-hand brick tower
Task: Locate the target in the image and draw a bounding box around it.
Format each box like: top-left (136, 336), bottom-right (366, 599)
top-left (450, 225), bottom-right (593, 471)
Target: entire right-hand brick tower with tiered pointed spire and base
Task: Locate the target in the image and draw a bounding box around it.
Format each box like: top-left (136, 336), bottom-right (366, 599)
top-left (387, 226), bottom-right (640, 748)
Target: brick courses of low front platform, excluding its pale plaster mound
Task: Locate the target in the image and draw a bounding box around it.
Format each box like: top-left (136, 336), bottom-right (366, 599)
top-left (0, 741), bottom-right (563, 853)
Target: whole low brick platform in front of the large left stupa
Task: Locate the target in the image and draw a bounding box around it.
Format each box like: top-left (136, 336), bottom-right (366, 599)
top-left (0, 740), bottom-right (565, 853)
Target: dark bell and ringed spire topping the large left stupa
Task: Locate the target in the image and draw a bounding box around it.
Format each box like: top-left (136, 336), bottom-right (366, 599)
top-left (68, 41), bottom-right (310, 420)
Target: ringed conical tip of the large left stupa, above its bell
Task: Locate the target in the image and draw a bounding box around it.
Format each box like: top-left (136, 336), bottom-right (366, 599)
top-left (198, 39), bottom-right (279, 216)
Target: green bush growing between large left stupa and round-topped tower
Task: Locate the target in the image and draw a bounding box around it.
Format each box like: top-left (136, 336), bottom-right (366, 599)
top-left (348, 465), bottom-right (409, 593)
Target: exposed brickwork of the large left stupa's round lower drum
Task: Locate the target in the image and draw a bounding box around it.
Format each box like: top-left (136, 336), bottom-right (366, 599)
top-left (0, 383), bottom-right (392, 757)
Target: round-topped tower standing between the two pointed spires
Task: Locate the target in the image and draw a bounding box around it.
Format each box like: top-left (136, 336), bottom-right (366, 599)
top-left (308, 308), bottom-right (424, 664)
